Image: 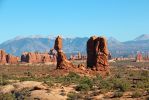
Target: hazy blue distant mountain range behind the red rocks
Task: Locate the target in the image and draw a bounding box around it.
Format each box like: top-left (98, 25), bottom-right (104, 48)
top-left (0, 34), bottom-right (149, 57)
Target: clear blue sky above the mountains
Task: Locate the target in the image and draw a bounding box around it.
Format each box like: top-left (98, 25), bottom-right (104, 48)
top-left (0, 0), bottom-right (149, 43)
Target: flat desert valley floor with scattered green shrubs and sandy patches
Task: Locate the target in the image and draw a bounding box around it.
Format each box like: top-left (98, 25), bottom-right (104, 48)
top-left (0, 60), bottom-right (149, 100)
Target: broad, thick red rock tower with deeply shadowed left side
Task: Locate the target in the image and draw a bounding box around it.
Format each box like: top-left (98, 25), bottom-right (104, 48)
top-left (87, 36), bottom-right (109, 74)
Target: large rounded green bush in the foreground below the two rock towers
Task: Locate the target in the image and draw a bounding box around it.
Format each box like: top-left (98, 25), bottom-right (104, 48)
top-left (76, 77), bottom-right (93, 91)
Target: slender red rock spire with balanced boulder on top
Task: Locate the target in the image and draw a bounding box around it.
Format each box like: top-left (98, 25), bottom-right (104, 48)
top-left (54, 36), bottom-right (73, 69)
